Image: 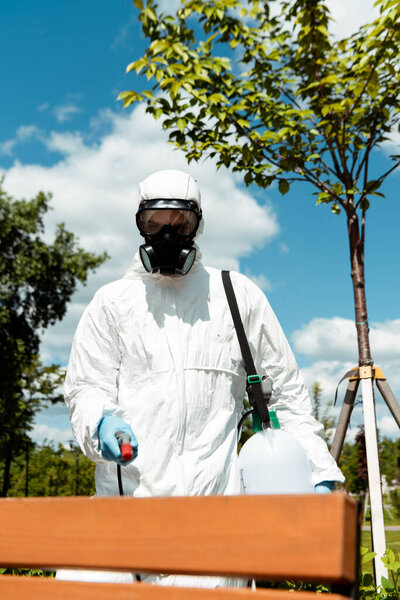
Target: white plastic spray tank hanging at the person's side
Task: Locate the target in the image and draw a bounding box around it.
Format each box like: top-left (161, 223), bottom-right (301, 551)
top-left (239, 396), bottom-right (315, 494)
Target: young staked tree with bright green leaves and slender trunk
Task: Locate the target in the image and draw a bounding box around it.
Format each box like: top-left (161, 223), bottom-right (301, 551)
top-left (119, 0), bottom-right (400, 372)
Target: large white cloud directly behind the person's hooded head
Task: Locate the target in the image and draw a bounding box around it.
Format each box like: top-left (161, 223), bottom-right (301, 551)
top-left (4, 106), bottom-right (279, 364)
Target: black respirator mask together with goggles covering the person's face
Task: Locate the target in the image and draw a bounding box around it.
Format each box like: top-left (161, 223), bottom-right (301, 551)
top-left (136, 199), bottom-right (201, 275)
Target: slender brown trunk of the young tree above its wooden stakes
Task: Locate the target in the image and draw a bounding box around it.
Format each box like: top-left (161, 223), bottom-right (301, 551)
top-left (347, 211), bottom-right (374, 366)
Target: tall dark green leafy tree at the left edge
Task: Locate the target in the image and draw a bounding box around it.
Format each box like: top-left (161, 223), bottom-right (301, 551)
top-left (0, 185), bottom-right (106, 496)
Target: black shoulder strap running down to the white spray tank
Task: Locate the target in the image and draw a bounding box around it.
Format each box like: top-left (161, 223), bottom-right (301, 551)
top-left (221, 271), bottom-right (270, 425)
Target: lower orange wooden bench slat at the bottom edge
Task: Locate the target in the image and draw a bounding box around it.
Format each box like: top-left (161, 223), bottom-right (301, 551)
top-left (0, 575), bottom-right (354, 600)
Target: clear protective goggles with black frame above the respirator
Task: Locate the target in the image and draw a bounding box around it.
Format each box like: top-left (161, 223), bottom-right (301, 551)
top-left (136, 200), bottom-right (201, 237)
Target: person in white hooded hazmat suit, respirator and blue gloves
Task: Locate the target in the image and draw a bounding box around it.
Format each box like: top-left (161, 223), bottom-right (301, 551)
top-left (57, 170), bottom-right (344, 587)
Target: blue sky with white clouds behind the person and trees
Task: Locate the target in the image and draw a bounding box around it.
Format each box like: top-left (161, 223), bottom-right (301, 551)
top-left (0, 0), bottom-right (400, 441)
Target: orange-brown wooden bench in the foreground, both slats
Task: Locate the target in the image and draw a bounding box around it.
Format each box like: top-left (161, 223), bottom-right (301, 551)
top-left (0, 492), bottom-right (359, 600)
